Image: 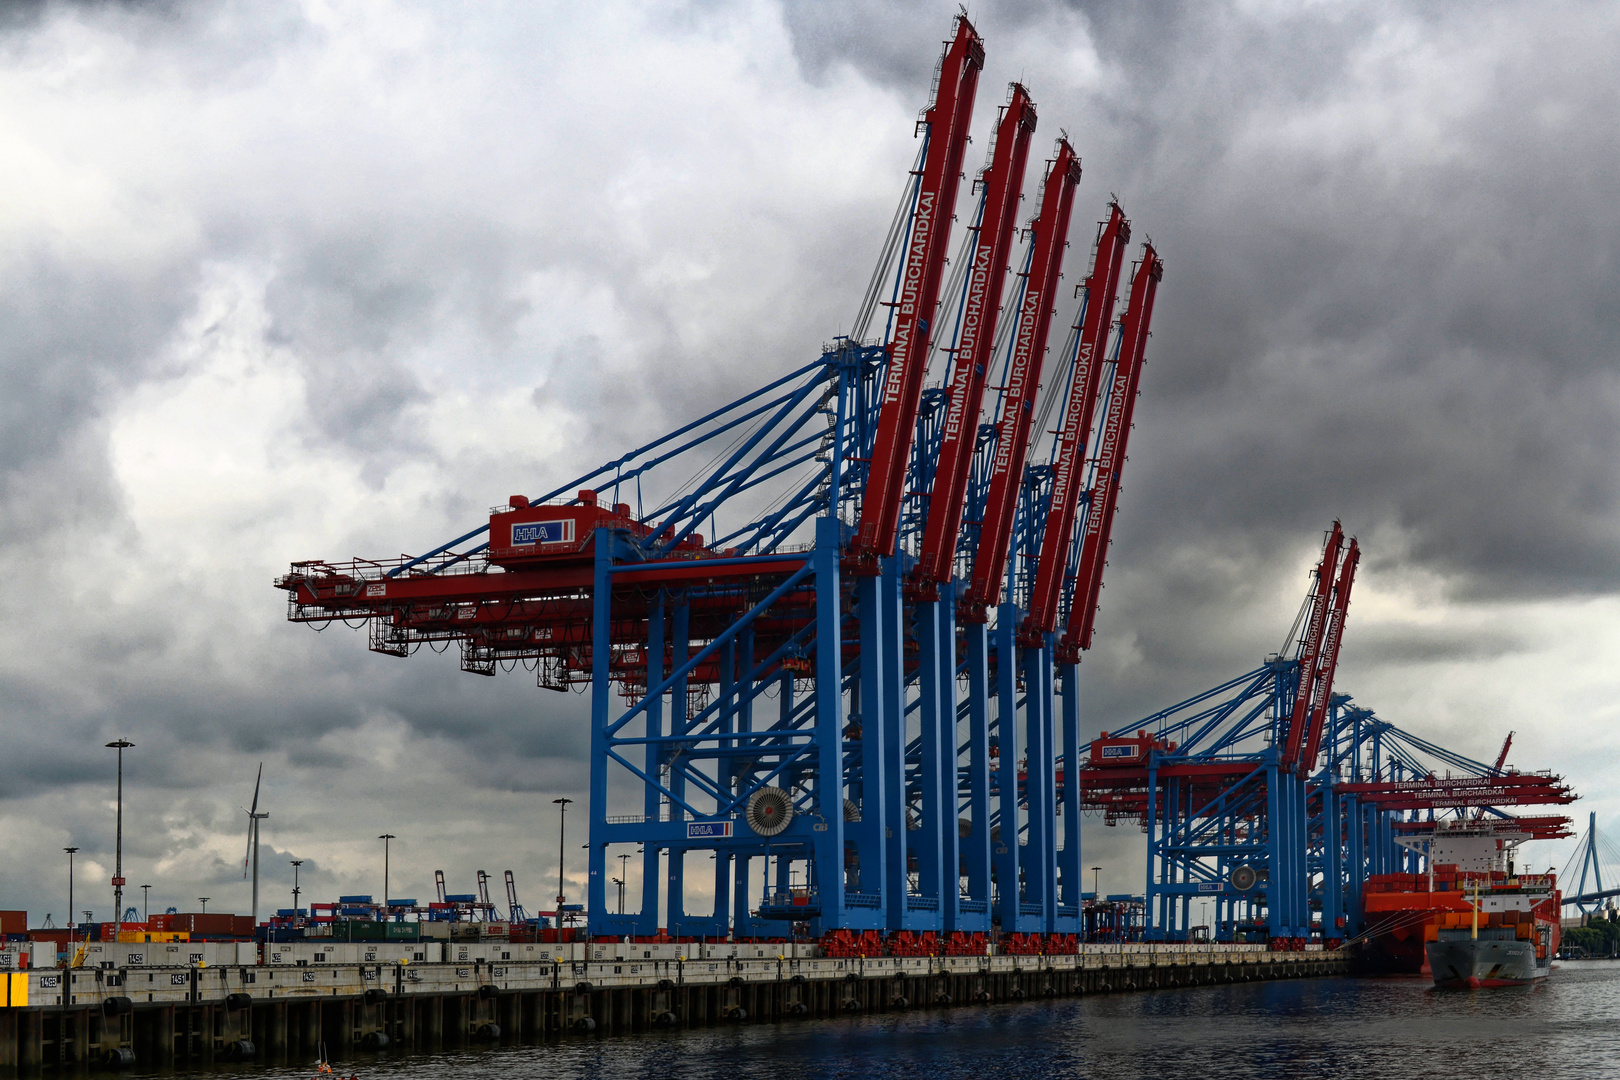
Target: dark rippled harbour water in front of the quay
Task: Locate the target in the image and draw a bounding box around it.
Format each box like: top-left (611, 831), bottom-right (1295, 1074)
top-left (129, 960), bottom-right (1620, 1080)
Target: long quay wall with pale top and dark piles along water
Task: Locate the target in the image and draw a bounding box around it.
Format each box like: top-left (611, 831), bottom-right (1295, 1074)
top-left (0, 942), bottom-right (1345, 1074)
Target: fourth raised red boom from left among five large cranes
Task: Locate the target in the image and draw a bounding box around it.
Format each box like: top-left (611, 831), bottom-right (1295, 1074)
top-left (1019, 202), bottom-right (1131, 646)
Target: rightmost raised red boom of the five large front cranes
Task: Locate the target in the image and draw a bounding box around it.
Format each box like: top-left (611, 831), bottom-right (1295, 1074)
top-left (1056, 244), bottom-right (1165, 664)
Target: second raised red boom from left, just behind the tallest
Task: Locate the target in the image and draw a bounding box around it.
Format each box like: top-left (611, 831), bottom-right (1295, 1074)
top-left (914, 83), bottom-right (1035, 586)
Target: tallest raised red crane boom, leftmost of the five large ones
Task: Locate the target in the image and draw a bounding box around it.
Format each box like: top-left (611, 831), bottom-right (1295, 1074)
top-left (849, 16), bottom-right (985, 573)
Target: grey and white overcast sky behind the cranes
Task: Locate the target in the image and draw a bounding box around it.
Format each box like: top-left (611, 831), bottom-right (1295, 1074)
top-left (0, 0), bottom-right (1620, 923)
